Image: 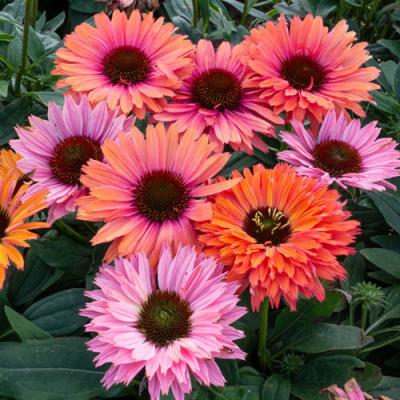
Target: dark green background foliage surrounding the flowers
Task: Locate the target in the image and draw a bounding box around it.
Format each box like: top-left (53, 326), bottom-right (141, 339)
top-left (0, 0), bottom-right (400, 400)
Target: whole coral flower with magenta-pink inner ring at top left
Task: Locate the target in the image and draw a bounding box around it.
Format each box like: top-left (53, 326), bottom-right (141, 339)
top-left (53, 10), bottom-right (193, 118)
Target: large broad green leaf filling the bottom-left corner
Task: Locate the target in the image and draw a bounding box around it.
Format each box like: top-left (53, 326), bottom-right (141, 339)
top-left (0, 337), bottom-right (114, 400)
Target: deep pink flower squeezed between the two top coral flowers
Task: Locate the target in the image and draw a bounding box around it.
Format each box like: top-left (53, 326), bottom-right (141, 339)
top-left (154, 40), bottom-right (283, 153)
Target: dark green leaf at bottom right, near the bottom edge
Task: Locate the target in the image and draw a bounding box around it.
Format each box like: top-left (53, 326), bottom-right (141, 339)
top-left (292, 355), bottom-right (372, 400)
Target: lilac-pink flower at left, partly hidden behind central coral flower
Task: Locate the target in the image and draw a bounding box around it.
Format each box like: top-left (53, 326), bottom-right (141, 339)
top-left (10, 96), bottom-right (131, 223)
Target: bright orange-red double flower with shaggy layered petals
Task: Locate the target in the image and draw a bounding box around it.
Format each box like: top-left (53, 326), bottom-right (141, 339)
top-left (198, 164), bottom-right (358, 310)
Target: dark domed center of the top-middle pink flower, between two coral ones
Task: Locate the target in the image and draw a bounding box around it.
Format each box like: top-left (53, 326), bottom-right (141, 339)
top-left (192, 68), bottom-right (242, 110)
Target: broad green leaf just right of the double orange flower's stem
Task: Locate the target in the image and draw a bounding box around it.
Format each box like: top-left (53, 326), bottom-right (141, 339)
top-left (290, 323), bottom-right (373, 354)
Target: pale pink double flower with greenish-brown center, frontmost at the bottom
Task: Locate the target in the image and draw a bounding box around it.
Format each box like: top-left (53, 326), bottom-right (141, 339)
top-left (81, 247), bottom-right (246, 400)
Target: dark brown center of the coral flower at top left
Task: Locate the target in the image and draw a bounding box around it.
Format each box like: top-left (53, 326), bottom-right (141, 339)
top-left (104, 46), bottom-right (150, 85)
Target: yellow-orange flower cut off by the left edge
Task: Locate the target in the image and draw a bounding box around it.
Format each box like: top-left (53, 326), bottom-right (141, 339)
top-left (0, 172), bottom-right (48, 289)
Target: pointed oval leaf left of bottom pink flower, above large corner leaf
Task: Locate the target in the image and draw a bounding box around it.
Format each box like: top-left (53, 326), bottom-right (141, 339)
top-left (24, 288), bottom-right (87, 336)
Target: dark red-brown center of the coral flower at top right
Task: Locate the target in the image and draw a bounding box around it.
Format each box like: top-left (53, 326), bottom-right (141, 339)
top-left (281, 55), bottom-right (325, 90)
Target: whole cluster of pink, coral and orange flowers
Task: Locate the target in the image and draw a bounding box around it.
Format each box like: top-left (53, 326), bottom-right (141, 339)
top-left (0, 7), bottom-right (400, 400)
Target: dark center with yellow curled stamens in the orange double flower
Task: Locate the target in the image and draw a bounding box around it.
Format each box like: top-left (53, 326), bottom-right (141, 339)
top-left (243, 207), bottom-right (292, 246)
